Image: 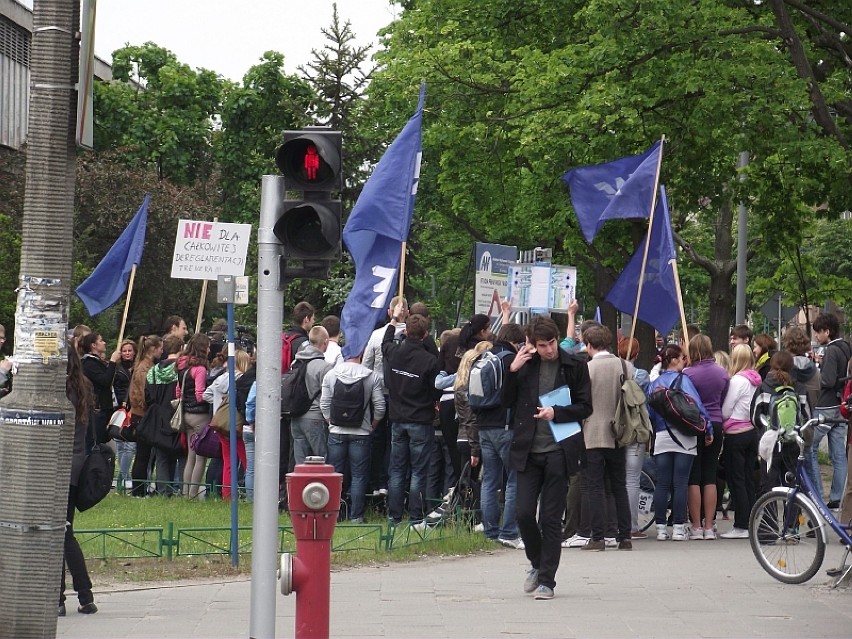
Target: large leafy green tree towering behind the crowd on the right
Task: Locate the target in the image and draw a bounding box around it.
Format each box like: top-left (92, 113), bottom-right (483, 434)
top-left (369, 0), bottom-right (850, 350)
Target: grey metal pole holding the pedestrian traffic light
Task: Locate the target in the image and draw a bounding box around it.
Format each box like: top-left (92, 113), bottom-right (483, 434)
top-left (249, 175), bottom-right (286, 639)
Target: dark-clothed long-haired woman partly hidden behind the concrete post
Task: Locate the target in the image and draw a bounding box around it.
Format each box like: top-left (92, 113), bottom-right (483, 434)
top-left (58, 342), bottom-right (98, 617)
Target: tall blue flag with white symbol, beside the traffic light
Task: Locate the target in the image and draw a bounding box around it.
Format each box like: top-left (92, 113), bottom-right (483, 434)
top-left (340, 84), bottom-right (426, 359)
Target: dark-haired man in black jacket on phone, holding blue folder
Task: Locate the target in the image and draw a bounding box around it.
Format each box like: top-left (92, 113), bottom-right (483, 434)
top-left (503, 317), bottom-right (592, 599)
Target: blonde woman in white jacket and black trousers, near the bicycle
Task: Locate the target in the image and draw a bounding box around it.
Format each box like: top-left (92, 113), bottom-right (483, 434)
top-left (721, 344), bottom-right (762, 539)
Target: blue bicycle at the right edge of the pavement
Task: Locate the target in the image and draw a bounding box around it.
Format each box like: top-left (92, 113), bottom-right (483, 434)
top-left (748, 416), bottom-right (852, 586)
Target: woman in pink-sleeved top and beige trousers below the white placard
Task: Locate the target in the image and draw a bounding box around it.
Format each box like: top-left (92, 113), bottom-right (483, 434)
top-left (177, 333), bottom-right (210, 498)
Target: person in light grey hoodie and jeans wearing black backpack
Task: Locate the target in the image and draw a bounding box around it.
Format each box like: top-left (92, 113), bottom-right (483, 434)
top-left (320, 357), bottom-right (386, 523)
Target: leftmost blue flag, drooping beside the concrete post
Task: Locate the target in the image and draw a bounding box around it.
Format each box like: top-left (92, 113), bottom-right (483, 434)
top-left (77, 194), bottom-right (151, 317)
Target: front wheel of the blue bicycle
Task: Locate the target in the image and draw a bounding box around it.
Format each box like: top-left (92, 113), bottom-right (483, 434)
top-left (748, 491), bottom-right (825, 584)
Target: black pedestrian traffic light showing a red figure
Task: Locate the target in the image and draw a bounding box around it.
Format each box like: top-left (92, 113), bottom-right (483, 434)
top-left (272, 127), bottom-right (343, 270)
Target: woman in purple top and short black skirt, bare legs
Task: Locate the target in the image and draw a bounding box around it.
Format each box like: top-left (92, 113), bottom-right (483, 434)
top-left (683, 333), bottom-right (730, 539)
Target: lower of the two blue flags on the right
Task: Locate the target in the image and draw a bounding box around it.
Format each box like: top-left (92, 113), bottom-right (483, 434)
top-left (606, 186), bottom-right (680, 335)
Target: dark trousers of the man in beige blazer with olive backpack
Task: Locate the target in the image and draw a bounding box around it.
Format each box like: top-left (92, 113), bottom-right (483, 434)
top-left (581, 448), bottom-right (630, 541)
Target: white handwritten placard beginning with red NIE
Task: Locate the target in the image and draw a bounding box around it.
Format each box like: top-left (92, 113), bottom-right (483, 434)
top-left (172, 220), bottom-right (251, 280)
